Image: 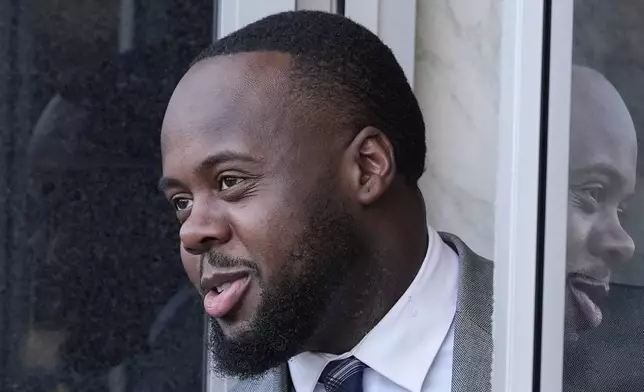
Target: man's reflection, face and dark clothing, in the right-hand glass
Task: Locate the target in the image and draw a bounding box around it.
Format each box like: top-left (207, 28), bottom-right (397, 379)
top-left (564, 66), bottom-right (640, 391)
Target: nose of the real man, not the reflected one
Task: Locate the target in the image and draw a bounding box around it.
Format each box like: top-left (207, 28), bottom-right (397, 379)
top-left (179, 201), bottom-right (231, 255)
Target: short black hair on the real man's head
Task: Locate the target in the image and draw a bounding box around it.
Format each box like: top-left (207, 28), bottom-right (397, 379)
top-left (192, 11), bottom-right (427, 185)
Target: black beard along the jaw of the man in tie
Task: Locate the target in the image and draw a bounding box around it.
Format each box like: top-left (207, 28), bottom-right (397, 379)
top-left (208, 201), bottom-right (368, 379)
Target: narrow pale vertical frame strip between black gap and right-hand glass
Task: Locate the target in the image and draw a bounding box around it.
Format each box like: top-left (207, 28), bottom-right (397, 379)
top-left (539, 0), bottom-right (573, 392)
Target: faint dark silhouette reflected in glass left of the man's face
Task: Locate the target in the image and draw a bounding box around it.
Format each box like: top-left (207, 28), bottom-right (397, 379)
top-left (20, 47), bottom-right (203, 392)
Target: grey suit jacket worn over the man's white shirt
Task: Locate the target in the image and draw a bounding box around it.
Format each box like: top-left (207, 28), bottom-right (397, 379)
top-left (219, 233), bottom-right (493, 392)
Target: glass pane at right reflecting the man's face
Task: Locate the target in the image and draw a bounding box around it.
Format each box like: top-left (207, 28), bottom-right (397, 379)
top-left (564, 0), bottom-right (644, 391)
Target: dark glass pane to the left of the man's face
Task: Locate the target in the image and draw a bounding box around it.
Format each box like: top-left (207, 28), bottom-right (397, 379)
top-left (0, 0), bottom-right (213, 391)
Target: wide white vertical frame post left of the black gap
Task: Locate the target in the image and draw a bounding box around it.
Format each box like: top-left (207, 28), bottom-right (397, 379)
top-left (492, 0), bottom-right (544, 392)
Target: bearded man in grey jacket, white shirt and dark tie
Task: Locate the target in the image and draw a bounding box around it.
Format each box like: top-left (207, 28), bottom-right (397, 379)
top-left (159, 11), bottom-right (492, 392)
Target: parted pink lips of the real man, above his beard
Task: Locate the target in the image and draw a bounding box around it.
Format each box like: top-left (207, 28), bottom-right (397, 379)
top-left (201, 270), bottom-right (250, 318)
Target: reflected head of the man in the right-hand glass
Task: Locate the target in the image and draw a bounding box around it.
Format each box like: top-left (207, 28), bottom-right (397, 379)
top-left (566, 66), bottom-right (637, 338)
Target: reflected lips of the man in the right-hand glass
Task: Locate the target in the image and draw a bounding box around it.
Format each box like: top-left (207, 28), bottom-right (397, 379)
top-left (568, 274), bottom-right (608, 329)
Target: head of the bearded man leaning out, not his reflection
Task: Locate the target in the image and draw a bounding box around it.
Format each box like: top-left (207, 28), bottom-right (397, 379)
top-left (160, 12), bottom-right (426, 376)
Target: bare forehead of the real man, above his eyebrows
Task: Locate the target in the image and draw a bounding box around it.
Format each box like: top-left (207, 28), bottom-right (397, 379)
top-left (162, 52), bottom-right (290, 151)
